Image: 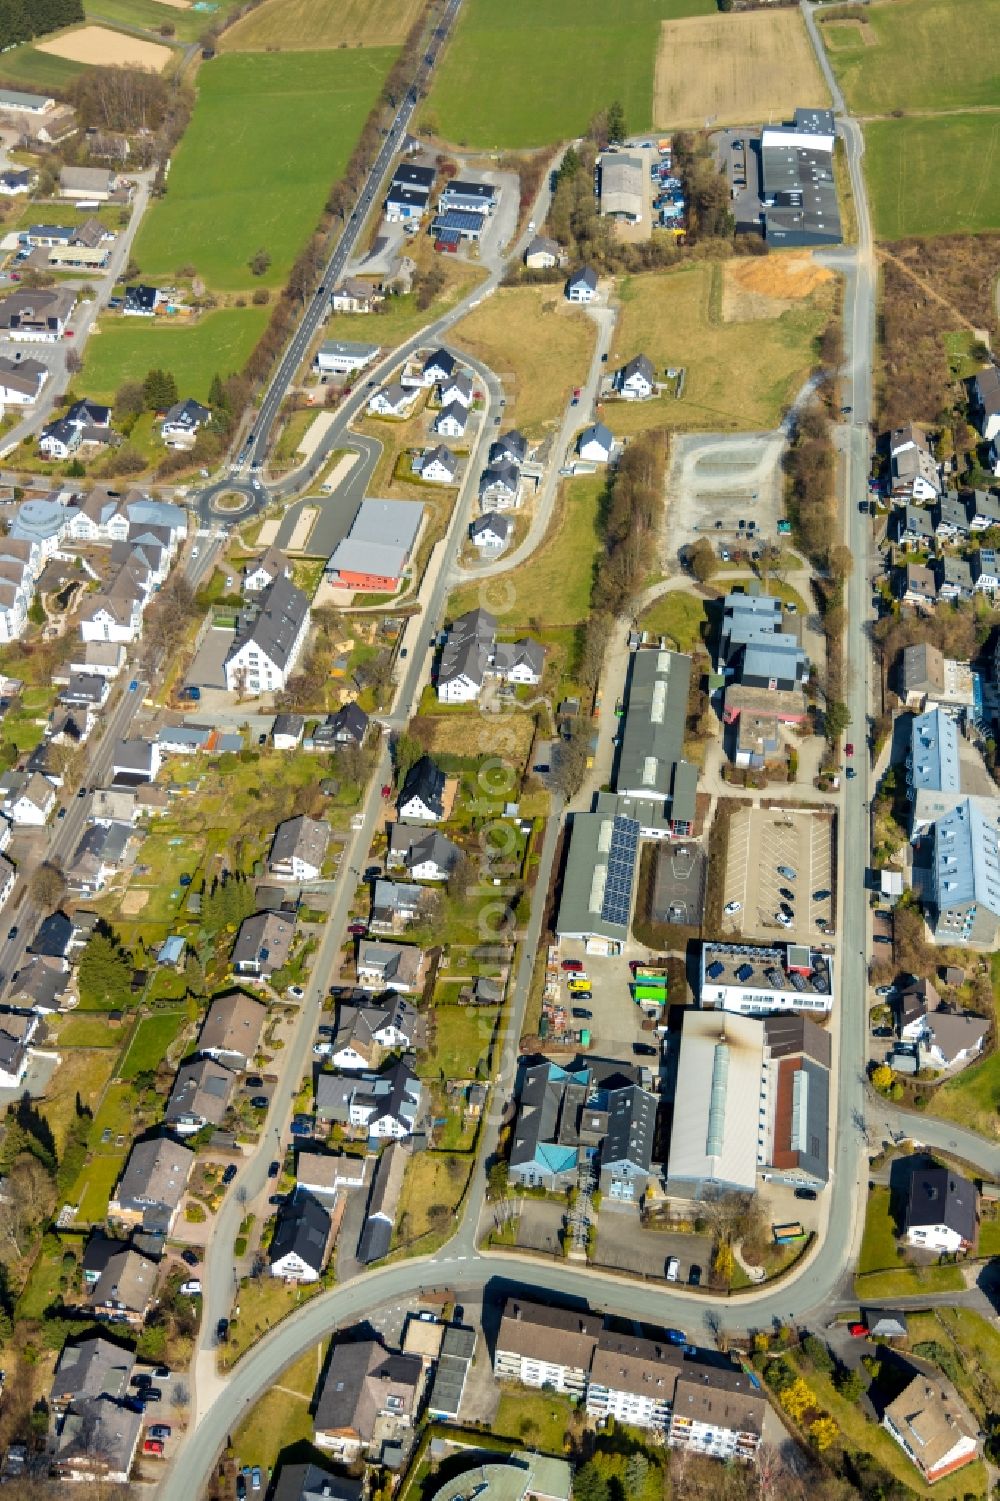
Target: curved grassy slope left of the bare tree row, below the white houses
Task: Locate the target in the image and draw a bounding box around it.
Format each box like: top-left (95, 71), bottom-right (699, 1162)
top-left (447, 473), bottom-right (607, 629)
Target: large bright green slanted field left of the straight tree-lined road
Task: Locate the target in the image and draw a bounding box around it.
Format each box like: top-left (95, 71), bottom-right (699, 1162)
top-left (134, 47), bottom-right (396, 291)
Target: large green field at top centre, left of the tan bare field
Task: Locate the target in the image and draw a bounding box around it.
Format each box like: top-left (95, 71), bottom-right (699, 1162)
top-left (425, 0), bottom-right (716, 149)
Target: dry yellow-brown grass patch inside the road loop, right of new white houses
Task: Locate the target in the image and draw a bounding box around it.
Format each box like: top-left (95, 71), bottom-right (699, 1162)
top-left (453, 287), bottom-right (598, 437)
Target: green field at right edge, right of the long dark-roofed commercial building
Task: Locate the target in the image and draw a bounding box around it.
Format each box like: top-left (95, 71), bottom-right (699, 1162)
top-left (865, 113), bottom-right (1000, 240)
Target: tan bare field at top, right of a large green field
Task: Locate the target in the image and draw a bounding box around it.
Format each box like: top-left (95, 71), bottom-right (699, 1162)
top-left (653, 9), bottom-right (830, 129)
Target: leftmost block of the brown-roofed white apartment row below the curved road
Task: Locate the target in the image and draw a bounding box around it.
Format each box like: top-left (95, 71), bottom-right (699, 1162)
top-left (492, 1298), bottom-right (602, 1397)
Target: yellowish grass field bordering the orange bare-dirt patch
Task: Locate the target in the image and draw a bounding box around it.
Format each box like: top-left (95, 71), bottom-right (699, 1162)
top-left (604, 261), bottom-right (833, 434)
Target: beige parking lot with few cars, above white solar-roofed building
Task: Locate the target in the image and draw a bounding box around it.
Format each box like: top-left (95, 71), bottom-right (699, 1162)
top-left (724, 808), bottom-right (836, 943)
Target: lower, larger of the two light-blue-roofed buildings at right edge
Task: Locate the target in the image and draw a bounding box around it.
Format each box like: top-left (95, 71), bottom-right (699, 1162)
top-left (929, 797), bottom-right (1000, 949)
